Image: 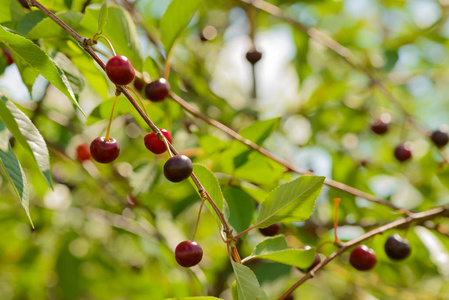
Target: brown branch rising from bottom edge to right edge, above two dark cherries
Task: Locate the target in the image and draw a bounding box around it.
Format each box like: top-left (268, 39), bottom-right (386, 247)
top-left (278, 206), bottom-right (449, 300)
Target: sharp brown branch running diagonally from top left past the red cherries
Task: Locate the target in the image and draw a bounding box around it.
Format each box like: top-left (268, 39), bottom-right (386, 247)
top-left (31, 0), bottom-right (232, 239)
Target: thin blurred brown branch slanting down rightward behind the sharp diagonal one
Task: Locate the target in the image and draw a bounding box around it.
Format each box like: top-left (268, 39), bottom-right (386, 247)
top-left (170, 93), bottom-right (400, 210)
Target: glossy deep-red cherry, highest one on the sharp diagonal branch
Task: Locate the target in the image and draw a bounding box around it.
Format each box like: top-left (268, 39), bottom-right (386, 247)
top-left (106, 55), bottom-right (136, 85)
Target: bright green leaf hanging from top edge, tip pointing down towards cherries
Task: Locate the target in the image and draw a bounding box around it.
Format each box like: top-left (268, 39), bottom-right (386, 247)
top-left (161, 0), bottom-right (201, 55)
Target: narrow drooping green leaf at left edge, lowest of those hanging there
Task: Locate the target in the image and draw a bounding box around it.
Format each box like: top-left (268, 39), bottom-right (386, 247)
top-left (0, 141), bottom-right (34, 228)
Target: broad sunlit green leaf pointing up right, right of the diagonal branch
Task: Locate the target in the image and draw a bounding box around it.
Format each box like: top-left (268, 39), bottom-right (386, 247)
top-left (256, 175), bottom-right (324, 228)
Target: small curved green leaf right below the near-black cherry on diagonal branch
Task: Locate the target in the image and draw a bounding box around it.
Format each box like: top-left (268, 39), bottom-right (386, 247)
top-left (190, 163), bottom-right (224, 224)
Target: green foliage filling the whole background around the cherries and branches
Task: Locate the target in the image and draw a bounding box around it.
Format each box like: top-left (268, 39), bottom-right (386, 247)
top-left (0, 0), bottom-right (449, 300)
